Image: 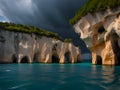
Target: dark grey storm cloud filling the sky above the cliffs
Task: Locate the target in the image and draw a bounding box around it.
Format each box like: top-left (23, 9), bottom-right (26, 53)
top-left (0, 0), bottom-right (89, 53)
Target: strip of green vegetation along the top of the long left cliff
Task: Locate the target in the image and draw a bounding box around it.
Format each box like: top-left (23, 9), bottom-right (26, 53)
top-left (0, 22), bottom-right (72, 42)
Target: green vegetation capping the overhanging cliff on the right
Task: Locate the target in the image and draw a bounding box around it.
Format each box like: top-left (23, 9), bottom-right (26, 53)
top-left (69, 0), bottom-right (120, 25)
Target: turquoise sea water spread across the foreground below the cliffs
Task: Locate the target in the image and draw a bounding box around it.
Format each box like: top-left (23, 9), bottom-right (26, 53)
top-left (0, 63), bottom-right (120, 90)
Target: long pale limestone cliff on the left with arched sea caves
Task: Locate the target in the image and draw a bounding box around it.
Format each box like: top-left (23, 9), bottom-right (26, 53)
top-left (0, 30), bottom-right (81, 63)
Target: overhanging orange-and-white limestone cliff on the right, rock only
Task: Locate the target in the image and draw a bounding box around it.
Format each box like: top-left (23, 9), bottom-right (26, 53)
top-left (74, 7), bottom-right (120, 65)
